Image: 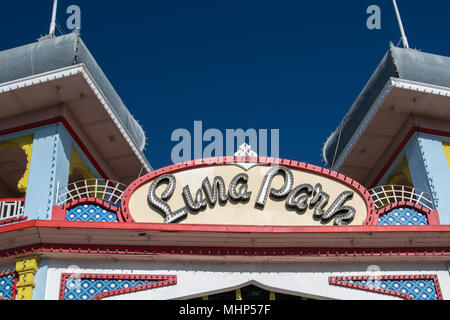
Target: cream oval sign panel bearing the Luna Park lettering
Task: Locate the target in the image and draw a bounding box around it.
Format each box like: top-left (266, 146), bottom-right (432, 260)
top-left (127, 159), bottom-right (368, 226)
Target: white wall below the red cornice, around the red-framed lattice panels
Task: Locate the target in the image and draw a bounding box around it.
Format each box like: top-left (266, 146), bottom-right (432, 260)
top-left (42, 260), bottom-right (450, 300)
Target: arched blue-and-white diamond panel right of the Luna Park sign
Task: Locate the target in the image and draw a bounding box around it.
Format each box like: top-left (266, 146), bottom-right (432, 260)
top-left (377, 208), bottom-right (428, 226)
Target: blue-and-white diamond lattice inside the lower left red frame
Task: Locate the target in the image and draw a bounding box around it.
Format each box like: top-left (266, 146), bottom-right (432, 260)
top-left (64, 278), bottom-right (156, 300)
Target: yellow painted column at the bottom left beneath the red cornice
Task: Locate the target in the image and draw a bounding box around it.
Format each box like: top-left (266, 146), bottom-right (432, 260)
top-left (16, 256), bottom-right (40, 300)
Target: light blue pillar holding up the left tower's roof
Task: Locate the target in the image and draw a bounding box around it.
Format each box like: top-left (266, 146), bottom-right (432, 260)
top-left (24, 123), bottom-right (72, 220)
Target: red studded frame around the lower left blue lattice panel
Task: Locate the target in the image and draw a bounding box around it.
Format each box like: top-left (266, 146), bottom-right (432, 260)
top-left (59, 273), bottom-right (177, 300)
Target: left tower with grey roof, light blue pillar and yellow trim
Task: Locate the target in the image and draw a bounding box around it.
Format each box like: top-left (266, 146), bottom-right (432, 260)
top-left (0, 33), bottom-right (150, 220)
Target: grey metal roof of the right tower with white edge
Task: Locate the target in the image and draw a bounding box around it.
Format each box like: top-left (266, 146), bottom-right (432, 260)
top-left (323, 44), bottom-right (450, 181)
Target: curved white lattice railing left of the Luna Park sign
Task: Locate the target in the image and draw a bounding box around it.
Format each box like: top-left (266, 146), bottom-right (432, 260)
top-left (56, 179), bottom-right (126, 206)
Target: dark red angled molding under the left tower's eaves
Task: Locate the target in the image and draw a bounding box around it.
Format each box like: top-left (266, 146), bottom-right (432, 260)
top-left (0, 116), bottom-right (109, 180)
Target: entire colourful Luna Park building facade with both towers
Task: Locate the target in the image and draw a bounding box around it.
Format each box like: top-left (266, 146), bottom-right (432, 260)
top-left (0, 33), bottom-right (450, 300)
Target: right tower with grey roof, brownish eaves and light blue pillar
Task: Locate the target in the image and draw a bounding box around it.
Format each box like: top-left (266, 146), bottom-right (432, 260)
top-left (323, 44), bottom-right (450, 224)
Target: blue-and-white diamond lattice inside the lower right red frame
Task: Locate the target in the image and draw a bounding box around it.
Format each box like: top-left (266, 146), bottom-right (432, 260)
top-left (346, 280), bottom-right (438, 300)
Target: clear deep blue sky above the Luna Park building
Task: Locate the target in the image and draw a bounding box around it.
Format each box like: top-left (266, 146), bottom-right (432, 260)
top-left (0, 0), bottom-right (450, 169)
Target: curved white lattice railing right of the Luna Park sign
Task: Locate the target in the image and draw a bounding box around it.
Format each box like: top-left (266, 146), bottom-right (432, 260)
top-left (369, 185), bottom-right (434, 210)
